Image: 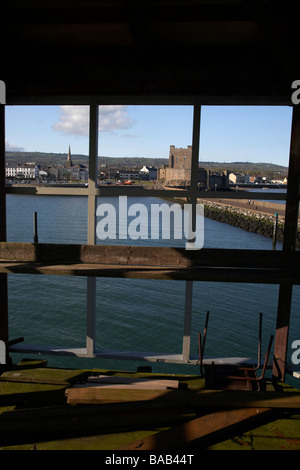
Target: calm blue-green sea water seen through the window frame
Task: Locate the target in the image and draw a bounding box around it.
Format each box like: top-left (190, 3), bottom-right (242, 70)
top-left (7, 195), bottom-right (300, 385)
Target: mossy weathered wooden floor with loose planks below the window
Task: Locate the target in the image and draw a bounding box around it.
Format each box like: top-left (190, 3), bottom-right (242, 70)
top-left (0, 361), bottom-right (300, 450)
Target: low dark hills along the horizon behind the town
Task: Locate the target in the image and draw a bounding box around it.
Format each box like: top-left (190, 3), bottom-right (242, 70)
top-left (6, 152), bottom-right (288, 174)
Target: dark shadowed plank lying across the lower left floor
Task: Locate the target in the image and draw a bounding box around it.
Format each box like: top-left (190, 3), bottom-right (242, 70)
top-left (0, 405), bottom-right (196, 446)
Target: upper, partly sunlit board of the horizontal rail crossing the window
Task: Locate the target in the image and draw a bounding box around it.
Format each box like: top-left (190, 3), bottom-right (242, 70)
top-left (0, 242), bottom-right (300, 269)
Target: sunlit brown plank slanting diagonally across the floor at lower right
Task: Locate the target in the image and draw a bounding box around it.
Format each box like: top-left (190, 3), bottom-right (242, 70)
top-left (119, 408), bottom-right (270, 450)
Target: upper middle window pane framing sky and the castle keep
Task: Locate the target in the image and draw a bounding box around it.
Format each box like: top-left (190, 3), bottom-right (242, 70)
top-left (98, 105), bottom-right (193, 189)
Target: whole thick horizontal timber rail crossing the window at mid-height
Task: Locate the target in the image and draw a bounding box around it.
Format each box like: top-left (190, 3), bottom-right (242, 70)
top-left (0, 243), bottom-right (300, 284)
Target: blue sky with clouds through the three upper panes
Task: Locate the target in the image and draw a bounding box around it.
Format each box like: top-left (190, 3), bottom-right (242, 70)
top-left (6, 105), bottom-right (292, 166)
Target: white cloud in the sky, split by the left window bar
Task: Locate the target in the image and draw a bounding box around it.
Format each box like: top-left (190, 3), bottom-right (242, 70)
top-left (52, 105), bottom-right (134, 136)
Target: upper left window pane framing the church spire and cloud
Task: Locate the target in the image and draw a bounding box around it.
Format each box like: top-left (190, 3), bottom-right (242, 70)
top-left (6, 106), bottom-right (89, 187)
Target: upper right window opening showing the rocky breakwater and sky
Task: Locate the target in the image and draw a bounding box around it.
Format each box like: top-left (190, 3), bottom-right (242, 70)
top-left (199, 106), bottom-right (292, 249)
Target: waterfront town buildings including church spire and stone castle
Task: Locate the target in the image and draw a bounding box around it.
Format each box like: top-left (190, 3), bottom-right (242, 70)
top-left (6, 145), bottom-right (284, 190)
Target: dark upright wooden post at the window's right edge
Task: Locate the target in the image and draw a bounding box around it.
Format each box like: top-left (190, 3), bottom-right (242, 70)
top-left (273, 106), bottom-right (300, 381)
